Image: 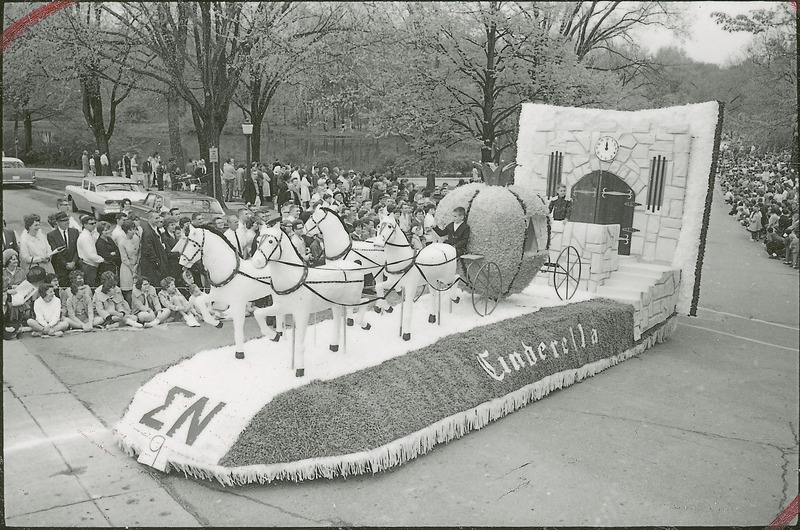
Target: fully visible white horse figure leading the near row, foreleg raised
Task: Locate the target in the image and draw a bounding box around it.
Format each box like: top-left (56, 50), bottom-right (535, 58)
top-left (253, 227), bottom-right (370, 377)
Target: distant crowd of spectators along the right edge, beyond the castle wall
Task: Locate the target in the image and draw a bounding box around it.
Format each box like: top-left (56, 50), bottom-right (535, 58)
top-left (718, 143), bottom-right (800, 269)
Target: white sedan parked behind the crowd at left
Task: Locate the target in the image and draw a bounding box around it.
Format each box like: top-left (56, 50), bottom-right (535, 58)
top-left (64, 177), bottom-right (147, 220)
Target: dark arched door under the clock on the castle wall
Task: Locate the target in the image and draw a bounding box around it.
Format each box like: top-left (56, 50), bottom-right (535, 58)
top-left (569, 170), bottom-right (636, 256)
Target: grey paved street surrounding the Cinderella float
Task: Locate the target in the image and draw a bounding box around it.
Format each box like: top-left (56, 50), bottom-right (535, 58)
top-left (3, 183), bottom-right (800, 526)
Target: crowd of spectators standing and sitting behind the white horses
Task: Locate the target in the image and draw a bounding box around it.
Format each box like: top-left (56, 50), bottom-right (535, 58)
top-left (3, 161), bottom-right (480, 339)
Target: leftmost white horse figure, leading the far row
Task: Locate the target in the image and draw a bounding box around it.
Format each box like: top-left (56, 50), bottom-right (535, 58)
top-left (173, 225), bottom-right (280, 359)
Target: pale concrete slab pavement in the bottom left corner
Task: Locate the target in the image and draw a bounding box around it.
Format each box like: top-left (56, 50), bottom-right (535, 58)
top-left (3, 340), bottom-right (199, 527)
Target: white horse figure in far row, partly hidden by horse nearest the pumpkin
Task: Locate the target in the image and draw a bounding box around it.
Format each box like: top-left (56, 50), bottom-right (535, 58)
top-left (304, 206), bottom-right (392, 316)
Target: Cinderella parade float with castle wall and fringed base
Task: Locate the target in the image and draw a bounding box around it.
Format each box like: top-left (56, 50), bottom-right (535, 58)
top-left (115, 102), bottom-right (722, 485)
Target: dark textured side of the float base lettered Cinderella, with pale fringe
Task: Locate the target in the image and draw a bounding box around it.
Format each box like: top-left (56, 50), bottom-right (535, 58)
top-left (150, 300), bottom-right (675, 485)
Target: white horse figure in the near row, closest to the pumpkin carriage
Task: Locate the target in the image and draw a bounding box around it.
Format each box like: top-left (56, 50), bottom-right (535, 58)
top-left (375, 215), bottom-right (461, 340)
